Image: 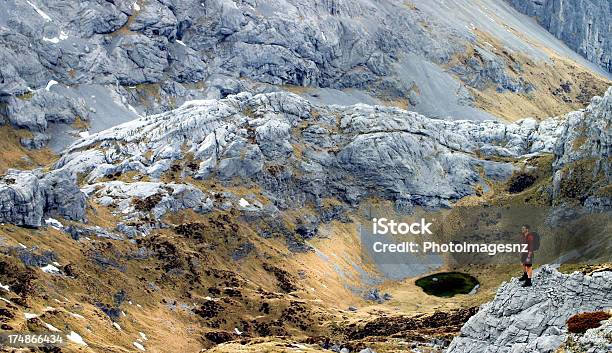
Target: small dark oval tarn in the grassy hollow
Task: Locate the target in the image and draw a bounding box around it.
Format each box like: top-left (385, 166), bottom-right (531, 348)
top-left (415, 272), bottom-right (479, 298)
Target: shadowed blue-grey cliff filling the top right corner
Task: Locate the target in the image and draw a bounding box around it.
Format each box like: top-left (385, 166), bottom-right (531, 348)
top-left (509, 0), bottom-right (612, 72)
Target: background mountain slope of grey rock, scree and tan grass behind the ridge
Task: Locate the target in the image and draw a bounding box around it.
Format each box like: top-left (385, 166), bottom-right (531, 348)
top-left (0, 0), bottom-right (610, 150)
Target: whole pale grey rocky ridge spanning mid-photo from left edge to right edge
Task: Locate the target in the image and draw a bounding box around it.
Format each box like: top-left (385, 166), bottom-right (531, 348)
top-left (2, 85), bottom-right (612, 226)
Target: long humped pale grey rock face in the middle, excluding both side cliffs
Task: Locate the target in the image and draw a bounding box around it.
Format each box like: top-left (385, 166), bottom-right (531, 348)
top-left (56, 93), bottom-right (562, 207)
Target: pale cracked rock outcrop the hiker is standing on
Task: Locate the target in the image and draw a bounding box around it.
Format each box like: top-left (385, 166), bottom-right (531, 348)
top-left (447, 266), bottom-right (612, 353)
